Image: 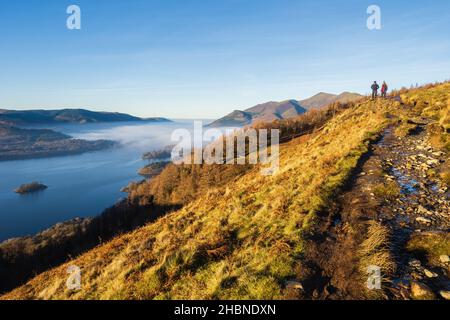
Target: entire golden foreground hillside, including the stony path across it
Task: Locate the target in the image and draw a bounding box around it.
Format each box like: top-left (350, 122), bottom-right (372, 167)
top-left (2, 84), bottom-right (450, 299)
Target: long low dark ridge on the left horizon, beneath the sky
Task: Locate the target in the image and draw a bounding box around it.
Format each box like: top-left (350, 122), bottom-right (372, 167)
top-left (0, 109), bottom-right (170, 125)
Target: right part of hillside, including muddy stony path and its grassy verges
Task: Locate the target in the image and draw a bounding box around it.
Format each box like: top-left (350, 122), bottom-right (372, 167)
top-left (303, 83), bottom-right (450, 300)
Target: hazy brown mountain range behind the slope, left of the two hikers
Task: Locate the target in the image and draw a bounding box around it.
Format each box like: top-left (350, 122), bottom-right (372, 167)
top-left (208, 92), bottom-right (362, 127)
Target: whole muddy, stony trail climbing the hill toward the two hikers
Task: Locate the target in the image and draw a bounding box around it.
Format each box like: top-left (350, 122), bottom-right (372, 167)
top-left (305, 111), bottom-right (450, 299)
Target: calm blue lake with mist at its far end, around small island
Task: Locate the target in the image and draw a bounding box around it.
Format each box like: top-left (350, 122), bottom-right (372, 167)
top-left (0, 121), bottom-right (218, 241)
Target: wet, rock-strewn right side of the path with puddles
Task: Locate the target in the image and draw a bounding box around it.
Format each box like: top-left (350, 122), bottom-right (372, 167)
top-left (369, 119), bottom-right (450, 299)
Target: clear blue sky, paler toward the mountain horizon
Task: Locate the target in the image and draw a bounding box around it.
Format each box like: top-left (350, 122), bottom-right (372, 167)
top-left (0, 0), bottom-right (450, 118)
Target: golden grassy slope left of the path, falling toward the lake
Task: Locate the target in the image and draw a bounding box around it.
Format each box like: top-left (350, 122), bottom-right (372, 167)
top-left (4, 92), bottom-right (398, 299)
